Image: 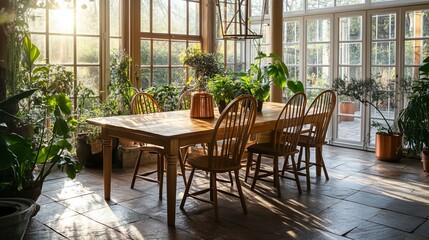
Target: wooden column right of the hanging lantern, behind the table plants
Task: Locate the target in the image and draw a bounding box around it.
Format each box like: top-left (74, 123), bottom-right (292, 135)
top-left (270, 0), bottom-right (283, 102)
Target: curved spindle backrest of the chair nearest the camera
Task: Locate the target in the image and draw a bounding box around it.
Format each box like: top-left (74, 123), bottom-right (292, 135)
top-left (208, 94), bottom-right (257, 169)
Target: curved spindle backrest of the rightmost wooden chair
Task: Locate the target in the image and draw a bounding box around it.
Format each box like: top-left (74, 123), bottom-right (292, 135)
top-left (306, 89), bottom-right (337, 144)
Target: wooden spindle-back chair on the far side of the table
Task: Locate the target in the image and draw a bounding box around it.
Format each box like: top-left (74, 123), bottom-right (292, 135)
top-left (131, 92), bottom-right (164, 198)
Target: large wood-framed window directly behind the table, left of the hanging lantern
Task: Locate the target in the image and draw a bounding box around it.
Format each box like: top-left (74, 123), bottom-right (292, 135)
top-left (139, 0), bottom-right (201, 88)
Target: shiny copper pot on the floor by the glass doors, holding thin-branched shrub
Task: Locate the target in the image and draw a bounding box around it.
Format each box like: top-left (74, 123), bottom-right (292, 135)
top-left (375, 133), bottom-right (402, 161)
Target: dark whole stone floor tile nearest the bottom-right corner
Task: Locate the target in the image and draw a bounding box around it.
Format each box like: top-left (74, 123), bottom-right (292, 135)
top-left (369, 210), bottom-right (426, 232)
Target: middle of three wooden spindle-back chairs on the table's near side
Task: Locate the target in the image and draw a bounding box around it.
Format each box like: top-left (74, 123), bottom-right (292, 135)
top-left (245, 93), bottom-right (307, 197)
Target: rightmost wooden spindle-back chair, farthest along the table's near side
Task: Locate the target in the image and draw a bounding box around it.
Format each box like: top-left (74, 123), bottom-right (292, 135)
top-left (298, 90), bottom-right (337, 191)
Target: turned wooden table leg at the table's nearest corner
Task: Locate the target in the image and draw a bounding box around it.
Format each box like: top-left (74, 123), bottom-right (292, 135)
top-left (167, 139), bottom-right (179, 226)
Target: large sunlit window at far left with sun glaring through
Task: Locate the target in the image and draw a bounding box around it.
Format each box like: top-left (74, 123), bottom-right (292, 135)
top-left (29, 0), bottom-right (101, 92)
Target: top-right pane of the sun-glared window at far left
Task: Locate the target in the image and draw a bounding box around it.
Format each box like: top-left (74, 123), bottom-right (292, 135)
top-left (76, 0), bottom-right (100, 34)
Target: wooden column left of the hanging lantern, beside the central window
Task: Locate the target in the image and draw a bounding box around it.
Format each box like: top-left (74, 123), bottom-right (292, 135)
top-left (201, 0), bottom-right (216, 53)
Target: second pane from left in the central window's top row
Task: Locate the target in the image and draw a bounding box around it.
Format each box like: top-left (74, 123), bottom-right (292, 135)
top-left (152, 0), bottom-right (168, 33)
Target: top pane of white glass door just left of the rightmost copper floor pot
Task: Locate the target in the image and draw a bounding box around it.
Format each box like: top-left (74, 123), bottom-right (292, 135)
top-left (339, 16), bottom-right (362, 41)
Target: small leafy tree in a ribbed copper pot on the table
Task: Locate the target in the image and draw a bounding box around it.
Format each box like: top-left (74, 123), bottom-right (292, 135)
top-left (182, 48), bottom-right (224, 118)
